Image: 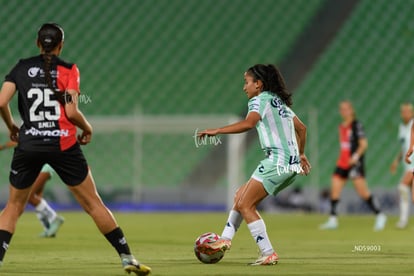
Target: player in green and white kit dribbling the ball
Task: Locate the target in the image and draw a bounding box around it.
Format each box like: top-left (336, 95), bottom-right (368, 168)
top-left (198, 64), bottom-right (311, 265)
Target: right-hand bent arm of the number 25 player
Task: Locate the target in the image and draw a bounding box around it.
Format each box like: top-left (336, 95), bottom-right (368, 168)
top-left (65, 89), bottom-right (92, 145)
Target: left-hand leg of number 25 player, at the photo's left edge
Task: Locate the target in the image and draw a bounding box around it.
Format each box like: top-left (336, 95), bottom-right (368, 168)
top-left (0, 185), bottom-right (30, 266)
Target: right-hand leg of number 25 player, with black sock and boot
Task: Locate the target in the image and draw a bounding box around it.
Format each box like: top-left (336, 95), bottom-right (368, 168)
top-left (68, 172), bottom-right (151, 275)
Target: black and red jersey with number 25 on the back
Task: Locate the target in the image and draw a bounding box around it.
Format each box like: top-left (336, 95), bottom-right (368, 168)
top-left (5, 55), bottom-right (80, 151)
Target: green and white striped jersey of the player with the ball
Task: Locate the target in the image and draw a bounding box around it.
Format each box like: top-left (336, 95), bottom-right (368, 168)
top-left (248, 91), bottom-right (299, 166)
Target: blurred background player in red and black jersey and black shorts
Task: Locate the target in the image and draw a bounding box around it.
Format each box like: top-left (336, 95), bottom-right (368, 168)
top-left (320, 101), bottom-right (387, 231)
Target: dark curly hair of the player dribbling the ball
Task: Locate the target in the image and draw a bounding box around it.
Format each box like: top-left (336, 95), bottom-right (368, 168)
top-left (247, 64), bottom-right (293, 106)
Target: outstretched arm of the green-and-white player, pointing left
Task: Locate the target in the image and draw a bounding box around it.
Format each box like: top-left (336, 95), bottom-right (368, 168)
top-left (197, 112), bottom-right (260, 137)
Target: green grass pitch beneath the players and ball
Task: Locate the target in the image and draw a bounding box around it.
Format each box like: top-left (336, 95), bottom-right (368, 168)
top-left (0, 212), bottom-right (414, 276)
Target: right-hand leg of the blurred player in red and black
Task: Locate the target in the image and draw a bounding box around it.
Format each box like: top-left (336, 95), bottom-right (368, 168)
top-left (352, 176), bottom-right (387, 231)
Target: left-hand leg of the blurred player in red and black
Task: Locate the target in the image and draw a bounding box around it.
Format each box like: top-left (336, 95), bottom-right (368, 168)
top-left (319, 174), bottom-right (347, 230)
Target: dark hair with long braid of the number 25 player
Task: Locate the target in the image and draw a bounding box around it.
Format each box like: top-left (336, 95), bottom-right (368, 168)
top-left (37, 23), bottom-right (65, 104)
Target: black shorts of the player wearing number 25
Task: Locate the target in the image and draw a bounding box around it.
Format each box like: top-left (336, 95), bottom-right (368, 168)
top-left (9, 143), bottom-right (89, 189)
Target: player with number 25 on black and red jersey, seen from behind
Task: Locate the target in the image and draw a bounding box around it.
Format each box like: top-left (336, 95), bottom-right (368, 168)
top-left (0, 23), bottom-right (151, 275)
